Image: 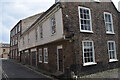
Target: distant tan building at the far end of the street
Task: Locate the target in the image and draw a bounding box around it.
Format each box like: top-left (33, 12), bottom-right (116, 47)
top-left (0, 43), bottom-right (10, 58)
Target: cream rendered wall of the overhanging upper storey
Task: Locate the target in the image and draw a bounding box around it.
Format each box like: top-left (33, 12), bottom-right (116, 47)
top-left (19, 9), bottom-right (64, 51)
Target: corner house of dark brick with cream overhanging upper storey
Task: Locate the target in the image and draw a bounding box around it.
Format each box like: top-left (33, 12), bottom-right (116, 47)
top-left (9, 0), bottom-right (120, 76)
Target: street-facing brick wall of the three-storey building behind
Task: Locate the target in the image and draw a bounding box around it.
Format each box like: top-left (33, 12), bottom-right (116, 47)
top-left (10, 21), bottom-right (22, 60)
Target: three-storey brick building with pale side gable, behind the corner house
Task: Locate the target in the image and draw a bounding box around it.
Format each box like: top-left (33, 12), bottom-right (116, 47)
top-left (10, 13), bottom-right (42, 61)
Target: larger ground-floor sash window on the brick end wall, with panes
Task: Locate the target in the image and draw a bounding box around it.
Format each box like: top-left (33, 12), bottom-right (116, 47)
top-left (82, 40), bottom-right (96, 66)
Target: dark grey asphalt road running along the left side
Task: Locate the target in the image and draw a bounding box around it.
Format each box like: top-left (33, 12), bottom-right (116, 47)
top-left (2, 60), bottom-right (52, 80)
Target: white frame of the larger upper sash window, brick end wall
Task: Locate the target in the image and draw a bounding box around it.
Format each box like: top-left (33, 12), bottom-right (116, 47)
top-left (78, 6), bottom-right (93, 33)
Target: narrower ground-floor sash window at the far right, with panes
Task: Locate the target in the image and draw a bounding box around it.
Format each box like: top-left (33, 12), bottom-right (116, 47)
top-left (108, 41), bottom-right (117, 62)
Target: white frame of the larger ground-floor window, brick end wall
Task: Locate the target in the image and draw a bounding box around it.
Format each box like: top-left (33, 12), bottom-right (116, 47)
top-left (82, 40), bottom-right (97, 66)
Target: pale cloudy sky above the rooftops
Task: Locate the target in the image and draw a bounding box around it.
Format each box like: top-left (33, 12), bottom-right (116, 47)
top-left (0, 0), bottom-right (120, 43)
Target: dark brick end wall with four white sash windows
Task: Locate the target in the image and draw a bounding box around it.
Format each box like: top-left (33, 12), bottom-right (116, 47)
top-left (62, 2), bottom-right (120, 75)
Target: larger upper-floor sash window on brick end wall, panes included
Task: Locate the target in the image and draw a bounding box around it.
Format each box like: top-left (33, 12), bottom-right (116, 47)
top-left (78, 6), bottom-right (92, 32)
